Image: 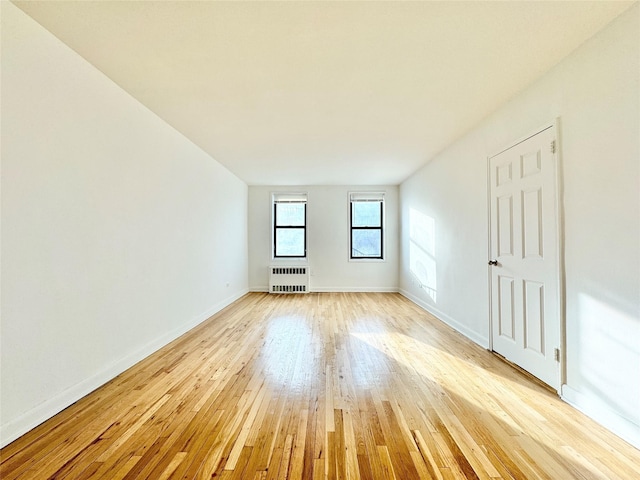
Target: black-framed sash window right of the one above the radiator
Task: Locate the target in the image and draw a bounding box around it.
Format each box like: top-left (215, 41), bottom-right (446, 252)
top-left (349, 192), bottom-right (384, 260)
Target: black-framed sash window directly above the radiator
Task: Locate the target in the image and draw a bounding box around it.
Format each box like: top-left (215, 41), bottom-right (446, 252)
top-left (273, 193), bottom-right (307, 258)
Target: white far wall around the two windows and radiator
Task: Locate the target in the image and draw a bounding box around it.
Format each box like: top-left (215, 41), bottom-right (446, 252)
top-left (249, 185), bottom-right (398, 292)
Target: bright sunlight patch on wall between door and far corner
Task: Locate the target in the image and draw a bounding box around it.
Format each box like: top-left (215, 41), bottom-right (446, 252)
top-left (409, 208), bottom-right (438, 304)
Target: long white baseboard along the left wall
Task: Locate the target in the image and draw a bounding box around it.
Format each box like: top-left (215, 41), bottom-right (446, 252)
top-left (0, 289), bottom-right (249, 448)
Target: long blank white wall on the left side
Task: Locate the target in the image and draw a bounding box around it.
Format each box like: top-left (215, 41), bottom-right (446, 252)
top-left (0, 2), bottom-right (248, 445)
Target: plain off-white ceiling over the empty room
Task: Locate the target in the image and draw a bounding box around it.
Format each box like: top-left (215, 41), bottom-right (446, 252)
top-left (14, 1), bottom-right (633, 185)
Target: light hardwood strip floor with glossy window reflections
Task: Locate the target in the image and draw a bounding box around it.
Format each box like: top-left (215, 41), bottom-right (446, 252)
top-left (0, 293), bottom-right (640, 480)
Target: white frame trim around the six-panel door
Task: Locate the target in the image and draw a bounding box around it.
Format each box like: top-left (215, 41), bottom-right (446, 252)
top-left (486, 117), bottom-right (567, 395)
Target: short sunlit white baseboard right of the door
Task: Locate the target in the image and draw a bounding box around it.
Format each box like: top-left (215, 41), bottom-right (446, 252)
top-left (561, 385), bottom-right (640, 449)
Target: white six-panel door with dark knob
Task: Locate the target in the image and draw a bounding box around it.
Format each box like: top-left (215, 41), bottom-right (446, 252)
top-left (489, 127), bottom-right (560, 390)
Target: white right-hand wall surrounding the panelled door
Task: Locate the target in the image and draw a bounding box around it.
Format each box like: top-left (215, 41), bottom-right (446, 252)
top-left (400, 4), bottom-right (640, 446)
